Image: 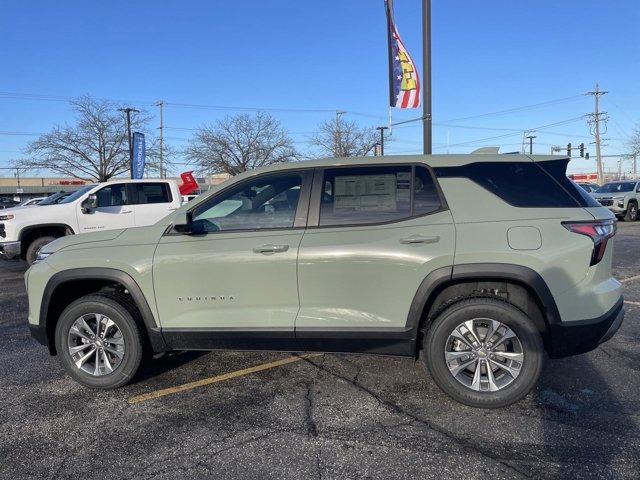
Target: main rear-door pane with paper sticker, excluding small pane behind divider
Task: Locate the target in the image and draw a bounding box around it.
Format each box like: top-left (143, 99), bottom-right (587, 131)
top-left (320, 166), bottom-right (411, 226)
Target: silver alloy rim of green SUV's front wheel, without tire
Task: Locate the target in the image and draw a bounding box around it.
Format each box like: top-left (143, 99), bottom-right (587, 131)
top-left (67, 313), bottom-right (125, 377)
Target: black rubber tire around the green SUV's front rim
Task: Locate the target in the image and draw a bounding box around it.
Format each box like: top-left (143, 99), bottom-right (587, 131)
top-left (55, 294), bottom-right (144, 389)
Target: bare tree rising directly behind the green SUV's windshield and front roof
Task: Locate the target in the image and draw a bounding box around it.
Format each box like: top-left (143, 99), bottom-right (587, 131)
top-left (185, 112), bottom-right (297, 175)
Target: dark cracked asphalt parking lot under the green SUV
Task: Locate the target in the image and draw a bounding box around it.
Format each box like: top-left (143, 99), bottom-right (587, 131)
top-left (0, 222), bottom-right (640, 479)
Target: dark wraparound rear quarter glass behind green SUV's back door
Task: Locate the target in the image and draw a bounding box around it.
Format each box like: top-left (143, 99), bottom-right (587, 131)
top-left (436, 159), bottom-right (599, 208)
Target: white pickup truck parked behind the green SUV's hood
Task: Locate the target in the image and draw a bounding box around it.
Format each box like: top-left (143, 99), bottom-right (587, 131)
top-left (0, 180), bottom-right (182, 265)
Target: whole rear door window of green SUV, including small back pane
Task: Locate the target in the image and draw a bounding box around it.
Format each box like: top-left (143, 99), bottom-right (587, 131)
top-left (319, 165), bottom-right (442, 226)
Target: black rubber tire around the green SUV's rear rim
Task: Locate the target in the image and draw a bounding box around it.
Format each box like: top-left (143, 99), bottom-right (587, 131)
top-left (423, 297), bottom-right (544, 408)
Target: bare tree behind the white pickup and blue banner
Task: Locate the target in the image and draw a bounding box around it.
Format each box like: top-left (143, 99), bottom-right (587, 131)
top-left (14, 96), bottom-right (166, 182)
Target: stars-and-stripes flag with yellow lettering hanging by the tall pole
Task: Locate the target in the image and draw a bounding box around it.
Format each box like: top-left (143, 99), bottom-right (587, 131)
top-left (384, 0), bottom-right (420, 108)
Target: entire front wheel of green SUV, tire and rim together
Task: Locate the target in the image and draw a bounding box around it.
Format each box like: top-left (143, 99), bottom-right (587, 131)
top-left (55, 295), bottom-right (143, 389)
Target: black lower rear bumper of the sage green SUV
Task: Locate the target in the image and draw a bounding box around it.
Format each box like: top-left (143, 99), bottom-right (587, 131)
top-left (547, 297), bottom-right (625, 358)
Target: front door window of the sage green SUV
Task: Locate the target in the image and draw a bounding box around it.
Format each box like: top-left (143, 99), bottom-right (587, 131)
top-left (193, 173), bottom-right (302, 232)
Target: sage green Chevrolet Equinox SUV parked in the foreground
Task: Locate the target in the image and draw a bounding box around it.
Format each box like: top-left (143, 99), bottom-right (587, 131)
top-left (25, 154), bottom-right (624, 407)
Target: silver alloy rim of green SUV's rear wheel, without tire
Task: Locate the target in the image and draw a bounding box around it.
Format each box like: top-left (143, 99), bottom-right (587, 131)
top-left (444, 318), bottom-right (525, 392)
